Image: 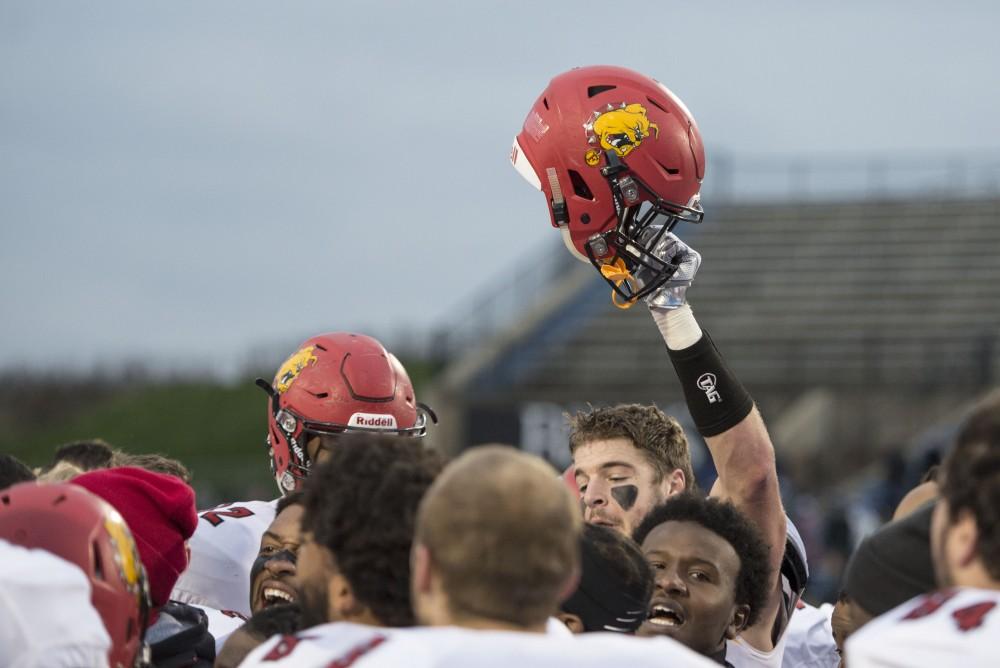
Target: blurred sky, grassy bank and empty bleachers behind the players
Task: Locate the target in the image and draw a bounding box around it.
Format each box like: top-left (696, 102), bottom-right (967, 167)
top-left (0, 1), bottom-right (1000, 602)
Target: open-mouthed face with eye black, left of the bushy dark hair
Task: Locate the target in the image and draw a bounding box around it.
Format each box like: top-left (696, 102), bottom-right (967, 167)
top-left (250, 504), bottom-right (302, 613)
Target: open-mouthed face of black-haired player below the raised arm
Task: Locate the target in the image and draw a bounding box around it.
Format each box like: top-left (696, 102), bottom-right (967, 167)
top-left (638, 522), bottom-right (749, 655)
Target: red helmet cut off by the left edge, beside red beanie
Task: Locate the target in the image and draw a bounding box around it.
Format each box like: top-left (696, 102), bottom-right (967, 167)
top-left (0, 482), bottom-right (149, 668)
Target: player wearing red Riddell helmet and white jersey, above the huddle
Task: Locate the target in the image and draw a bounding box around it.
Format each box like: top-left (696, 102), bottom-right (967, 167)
top-left (172, 332), bottom-right (435, 617)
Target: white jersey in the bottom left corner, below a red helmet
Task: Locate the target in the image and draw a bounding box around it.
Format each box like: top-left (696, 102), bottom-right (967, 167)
top-left (0, 539), bottom-right (111, 668)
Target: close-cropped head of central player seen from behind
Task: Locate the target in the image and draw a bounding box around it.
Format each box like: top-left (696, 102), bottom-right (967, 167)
top-left (416, 446), bottom-right (582, 627)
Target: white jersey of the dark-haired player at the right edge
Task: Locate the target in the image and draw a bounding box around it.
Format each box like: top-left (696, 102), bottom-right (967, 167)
top-left (846, 588), bottom-right (1000, 668)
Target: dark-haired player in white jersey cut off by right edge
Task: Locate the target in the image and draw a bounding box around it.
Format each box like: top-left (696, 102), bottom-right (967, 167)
top-left (847, 392), bottom-right (1000, 668)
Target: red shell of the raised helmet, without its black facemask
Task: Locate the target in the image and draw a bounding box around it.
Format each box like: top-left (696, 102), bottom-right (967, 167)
top-left (511, 66), bottom-right (705, 259)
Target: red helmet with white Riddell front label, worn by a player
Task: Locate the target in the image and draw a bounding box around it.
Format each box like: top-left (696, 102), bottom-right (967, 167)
top-left (257, 332), bottom-right (437, 494)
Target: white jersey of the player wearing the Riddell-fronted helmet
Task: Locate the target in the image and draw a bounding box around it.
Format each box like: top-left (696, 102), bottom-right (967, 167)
top-left (170, 499), bottom-right (278, 616)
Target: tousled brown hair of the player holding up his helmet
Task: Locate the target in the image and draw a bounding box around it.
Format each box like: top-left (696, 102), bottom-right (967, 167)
top-left (569, 404), bottom-right (697, 490)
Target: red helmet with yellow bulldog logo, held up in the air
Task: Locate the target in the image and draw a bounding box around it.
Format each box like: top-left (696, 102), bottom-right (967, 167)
top-left (510, 66), bottom-right (705, 304)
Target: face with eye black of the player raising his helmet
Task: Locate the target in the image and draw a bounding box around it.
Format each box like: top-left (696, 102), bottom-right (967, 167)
top-left (573, 438), bottom-right (670, 537)
